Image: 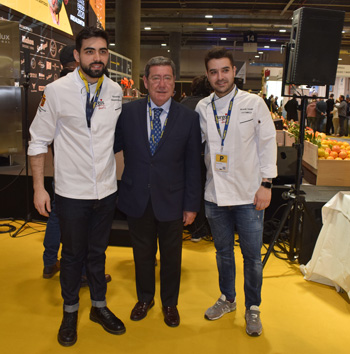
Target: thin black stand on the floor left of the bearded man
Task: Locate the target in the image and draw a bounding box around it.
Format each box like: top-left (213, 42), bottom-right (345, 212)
top-left (11, 66), bottom-right (32, 237)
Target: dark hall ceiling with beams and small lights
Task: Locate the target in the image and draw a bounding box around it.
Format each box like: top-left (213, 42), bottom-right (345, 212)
top-left (106, 0), bottom-right (350, 54)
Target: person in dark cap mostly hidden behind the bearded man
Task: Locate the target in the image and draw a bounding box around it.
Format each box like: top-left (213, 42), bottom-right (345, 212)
top-left (43, 45), bottom-right (112, 287)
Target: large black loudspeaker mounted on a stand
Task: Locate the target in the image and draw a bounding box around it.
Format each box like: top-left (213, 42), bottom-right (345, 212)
top-left (285, 7), bottom-right (345, 86)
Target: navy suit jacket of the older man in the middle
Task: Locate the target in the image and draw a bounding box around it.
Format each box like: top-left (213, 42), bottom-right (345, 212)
top-left (114, 99), bottom-right (201, 221)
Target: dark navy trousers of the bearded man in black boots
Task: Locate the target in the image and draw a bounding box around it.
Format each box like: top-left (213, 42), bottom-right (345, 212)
top-left (55, 193), bottom-right (117, 307)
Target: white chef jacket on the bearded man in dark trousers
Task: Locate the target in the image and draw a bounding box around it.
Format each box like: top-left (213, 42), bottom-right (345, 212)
top-left (28, 69), bottom-right (123, 199)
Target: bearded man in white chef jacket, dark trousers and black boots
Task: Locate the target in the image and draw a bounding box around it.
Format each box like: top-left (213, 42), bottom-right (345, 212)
top-left (28, 27), bottom-right (125, 346)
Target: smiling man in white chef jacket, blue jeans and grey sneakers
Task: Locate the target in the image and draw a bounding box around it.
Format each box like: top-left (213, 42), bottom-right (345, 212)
top-left (196, 47), bottom-right (277, 336)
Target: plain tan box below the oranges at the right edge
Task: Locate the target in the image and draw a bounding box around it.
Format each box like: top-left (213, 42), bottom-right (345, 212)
top-left (303, 141), bottom-right (350, 187)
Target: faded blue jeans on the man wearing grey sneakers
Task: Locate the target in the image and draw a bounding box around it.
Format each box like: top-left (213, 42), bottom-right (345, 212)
top-left (205, 201), bottom-right (264, 309)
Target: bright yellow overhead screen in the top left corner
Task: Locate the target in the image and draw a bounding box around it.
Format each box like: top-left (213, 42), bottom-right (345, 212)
top-left (1, 0), bottom-right (86, 35)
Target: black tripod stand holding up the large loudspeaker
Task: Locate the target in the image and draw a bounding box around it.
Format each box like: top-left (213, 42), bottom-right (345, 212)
top-left (262, 96), bottom-right (307, 267)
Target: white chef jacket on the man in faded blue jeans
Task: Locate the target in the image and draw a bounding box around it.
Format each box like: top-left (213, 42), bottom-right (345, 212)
top-left (196, 89), bottom-right (277, 206)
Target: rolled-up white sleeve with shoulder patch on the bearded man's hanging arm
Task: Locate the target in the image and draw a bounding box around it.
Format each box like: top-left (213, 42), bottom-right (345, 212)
top-left (28, 85), bottom-right (58, 156)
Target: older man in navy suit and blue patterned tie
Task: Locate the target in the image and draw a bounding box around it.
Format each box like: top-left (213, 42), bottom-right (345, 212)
top-left (115, 57), bottom-right (201, 327)
